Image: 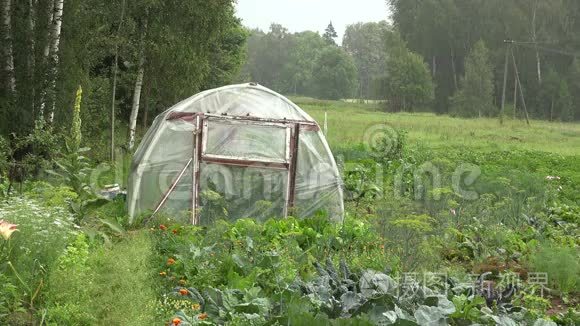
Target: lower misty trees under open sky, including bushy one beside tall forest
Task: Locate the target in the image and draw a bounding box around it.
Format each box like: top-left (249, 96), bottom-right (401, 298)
top-left (241, 21), bottom-right (434, 110)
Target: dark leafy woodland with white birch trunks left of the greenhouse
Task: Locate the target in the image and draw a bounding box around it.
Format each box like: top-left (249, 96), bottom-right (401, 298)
top-left (0, 0), bottom-right (248, 158)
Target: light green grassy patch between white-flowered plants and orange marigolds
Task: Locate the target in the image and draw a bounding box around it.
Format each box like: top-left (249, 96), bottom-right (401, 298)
top-left (46, 230), bottom-right (161, 325)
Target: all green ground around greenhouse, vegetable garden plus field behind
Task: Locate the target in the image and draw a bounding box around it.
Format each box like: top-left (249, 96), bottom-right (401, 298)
top-left (0, 98), bottom-right (580, 326)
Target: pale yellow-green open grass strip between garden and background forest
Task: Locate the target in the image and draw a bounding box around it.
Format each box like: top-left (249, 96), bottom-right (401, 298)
top-left (292, 98), bottom-right (580, 155)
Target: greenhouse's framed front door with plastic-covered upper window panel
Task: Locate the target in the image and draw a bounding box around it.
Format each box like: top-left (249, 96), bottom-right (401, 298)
top-left (192, 114), bottom-right (304, 224)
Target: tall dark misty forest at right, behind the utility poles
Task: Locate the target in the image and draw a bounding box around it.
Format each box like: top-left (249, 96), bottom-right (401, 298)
top-left (387, 0), bottom-right (580, 121)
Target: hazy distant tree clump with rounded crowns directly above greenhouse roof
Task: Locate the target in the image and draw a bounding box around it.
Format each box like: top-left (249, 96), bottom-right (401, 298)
top-left (240, 23), bottom-right (356, 99)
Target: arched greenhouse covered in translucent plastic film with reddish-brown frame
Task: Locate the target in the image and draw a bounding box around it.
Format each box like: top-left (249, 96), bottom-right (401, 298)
top-left (128, 83), bottom-right (344, 225)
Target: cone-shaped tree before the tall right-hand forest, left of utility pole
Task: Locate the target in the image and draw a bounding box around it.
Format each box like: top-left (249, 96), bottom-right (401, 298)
top-left (452, 41), bottom-right (494, 117)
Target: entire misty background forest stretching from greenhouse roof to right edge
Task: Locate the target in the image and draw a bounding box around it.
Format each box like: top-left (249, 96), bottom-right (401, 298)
top-left (245, 0), bottom-right (580, 121)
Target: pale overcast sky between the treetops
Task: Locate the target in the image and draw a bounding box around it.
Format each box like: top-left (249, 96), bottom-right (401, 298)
top-left (237, 0), bottom-right (389, 44)
